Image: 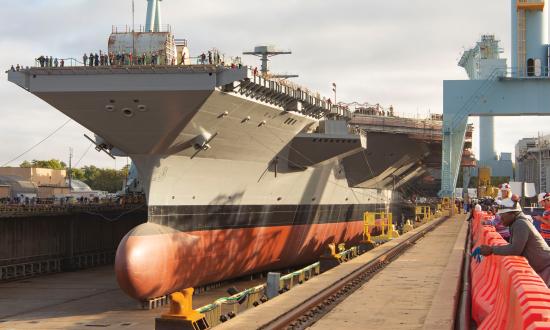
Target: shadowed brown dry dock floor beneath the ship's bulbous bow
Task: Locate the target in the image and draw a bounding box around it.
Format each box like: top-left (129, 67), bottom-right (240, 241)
top-left (0, 266), bottom-right (265, 330)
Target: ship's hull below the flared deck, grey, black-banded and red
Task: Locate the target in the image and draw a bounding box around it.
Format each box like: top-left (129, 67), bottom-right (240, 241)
top-left (115, 150), bottom-right (394, 300)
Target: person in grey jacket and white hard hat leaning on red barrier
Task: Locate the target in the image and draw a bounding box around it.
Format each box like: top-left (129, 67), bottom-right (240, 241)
top-left (474, 199), bottom-right (550, 287)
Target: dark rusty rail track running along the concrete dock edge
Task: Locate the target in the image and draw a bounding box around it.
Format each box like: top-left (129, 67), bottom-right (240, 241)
top-left (259, 216), bottom-right (450, 330)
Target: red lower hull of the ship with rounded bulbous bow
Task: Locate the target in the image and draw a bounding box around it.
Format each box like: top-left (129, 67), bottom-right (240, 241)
top-left (115, 220), bottom-right (363, 300)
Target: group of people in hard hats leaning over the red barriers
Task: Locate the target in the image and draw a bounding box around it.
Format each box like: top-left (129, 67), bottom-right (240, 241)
top-left (469, 184), bottom-right (550, 287)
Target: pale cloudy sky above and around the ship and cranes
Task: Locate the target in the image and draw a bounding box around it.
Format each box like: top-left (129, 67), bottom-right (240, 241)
top-left (0, 0), bottom-right (550, 168)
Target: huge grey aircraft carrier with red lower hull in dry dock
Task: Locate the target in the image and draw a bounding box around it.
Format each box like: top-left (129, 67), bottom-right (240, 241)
top-left (8, 0), bottom-right (474, 300)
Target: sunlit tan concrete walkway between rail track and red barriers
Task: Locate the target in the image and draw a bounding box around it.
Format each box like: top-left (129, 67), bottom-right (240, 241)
top-left (311, 216), bottom-right (467, 330)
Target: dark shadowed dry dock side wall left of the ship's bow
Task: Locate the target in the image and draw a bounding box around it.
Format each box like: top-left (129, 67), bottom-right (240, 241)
top-left (0, 205), bottom-right (147, 281)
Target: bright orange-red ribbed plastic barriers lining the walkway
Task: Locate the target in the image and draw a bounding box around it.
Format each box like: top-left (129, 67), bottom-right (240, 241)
top-left (471, 212), bottom-right (550, 330)
